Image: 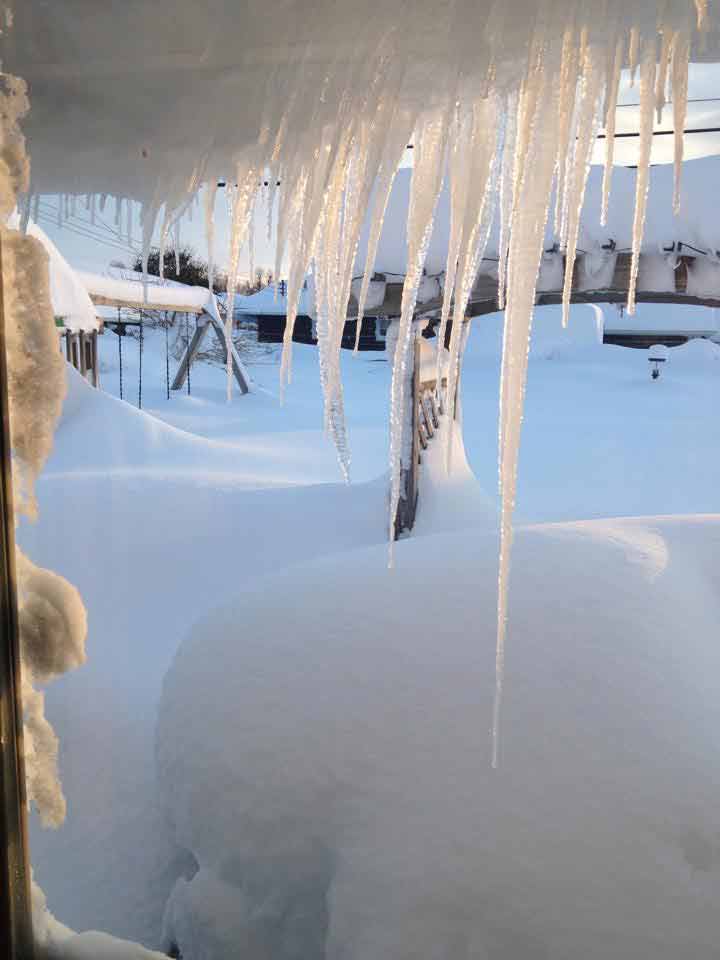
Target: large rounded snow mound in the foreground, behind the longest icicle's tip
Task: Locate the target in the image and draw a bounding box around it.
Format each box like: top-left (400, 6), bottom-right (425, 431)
top-left (157, 517), bottom-right (720, 960)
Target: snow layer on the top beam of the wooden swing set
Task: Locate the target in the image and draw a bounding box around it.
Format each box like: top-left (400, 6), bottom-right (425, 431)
top-left (78, 271), bottom-right (220, 319)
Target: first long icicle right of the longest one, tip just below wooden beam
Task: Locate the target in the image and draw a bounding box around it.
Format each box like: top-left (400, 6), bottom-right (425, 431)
top-left (562, 47), bottom-right (603, 327)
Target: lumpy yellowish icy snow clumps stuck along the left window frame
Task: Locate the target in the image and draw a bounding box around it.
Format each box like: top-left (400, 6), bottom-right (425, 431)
top-left (0, 77), bottom-right (87, 844)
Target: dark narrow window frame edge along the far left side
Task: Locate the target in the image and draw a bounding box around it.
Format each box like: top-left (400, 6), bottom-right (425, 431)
top-left (0, 227), bottom-right (34, 960)
